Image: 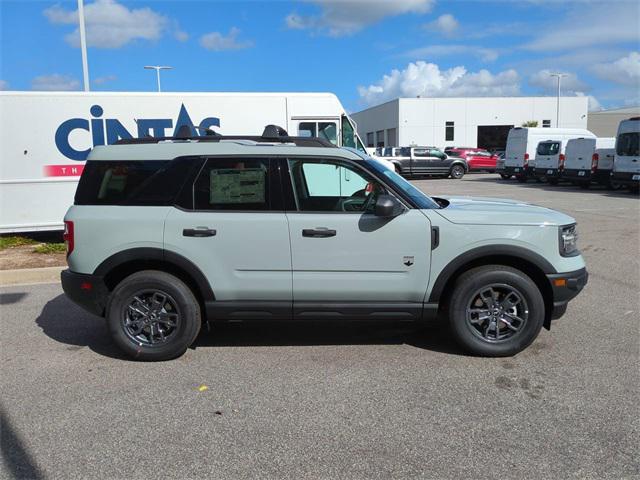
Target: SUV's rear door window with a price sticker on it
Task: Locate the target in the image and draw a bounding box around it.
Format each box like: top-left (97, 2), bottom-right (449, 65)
top-left (193, 158), bottom-right (270, 210)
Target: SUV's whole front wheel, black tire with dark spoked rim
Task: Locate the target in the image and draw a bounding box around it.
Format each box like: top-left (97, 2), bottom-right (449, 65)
top-left (448, 265), bottom-right (545, 357)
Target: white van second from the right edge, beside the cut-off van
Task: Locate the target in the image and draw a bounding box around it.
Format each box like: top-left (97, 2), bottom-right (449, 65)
top-left (562, 137), bottom-right (616, 188)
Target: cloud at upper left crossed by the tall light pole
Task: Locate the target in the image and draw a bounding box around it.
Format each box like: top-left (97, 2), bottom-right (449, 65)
top-left (44, 0), bottom-right (169, 48)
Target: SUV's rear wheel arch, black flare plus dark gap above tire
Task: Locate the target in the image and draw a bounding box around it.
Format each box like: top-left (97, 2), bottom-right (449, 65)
top-left (94, 247), bottom-right (215, 306)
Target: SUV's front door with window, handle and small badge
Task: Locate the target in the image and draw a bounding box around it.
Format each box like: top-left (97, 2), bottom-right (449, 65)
top-left (283, 158), bottom-right (431, 317)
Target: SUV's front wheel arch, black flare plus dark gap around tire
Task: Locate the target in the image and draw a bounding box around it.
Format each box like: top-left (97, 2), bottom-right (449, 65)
top-left (429, 245), bottom-right (557, 329)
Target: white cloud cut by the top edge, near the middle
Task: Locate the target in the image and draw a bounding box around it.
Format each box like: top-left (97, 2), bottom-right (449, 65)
top-left (285, 0), bottom-right (435, 37)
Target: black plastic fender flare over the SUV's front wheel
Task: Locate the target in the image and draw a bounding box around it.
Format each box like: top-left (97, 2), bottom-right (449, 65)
top-left (429, 245), bottom-right (558, 303)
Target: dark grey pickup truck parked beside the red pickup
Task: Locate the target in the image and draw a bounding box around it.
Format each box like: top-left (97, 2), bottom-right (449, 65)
top-left (389, 147), bottom-right (468, 179)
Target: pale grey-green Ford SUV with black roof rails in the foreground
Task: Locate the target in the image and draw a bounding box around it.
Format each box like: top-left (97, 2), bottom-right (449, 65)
top-left (62, 126), bottom-right (587, 360)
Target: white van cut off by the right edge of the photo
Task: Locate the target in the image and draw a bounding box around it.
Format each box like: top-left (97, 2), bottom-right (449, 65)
top-left (611, 117), bottom-right (640, 190)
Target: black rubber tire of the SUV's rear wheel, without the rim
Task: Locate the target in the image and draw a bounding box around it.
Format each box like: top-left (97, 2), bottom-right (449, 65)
top-left (106, 271), bottom-right (201, 361)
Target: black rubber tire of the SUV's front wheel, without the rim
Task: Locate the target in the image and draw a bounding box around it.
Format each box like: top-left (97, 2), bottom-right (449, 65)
top-left (449, 266), bottom-right (545, 356)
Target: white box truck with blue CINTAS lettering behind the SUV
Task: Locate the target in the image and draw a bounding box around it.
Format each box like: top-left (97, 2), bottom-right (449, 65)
top-left (0, 91), bottom-right (365, 233)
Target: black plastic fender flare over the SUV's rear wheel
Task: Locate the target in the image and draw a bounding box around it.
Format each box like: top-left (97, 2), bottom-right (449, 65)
top-left (93, 247), bottom-right (215, 301)
